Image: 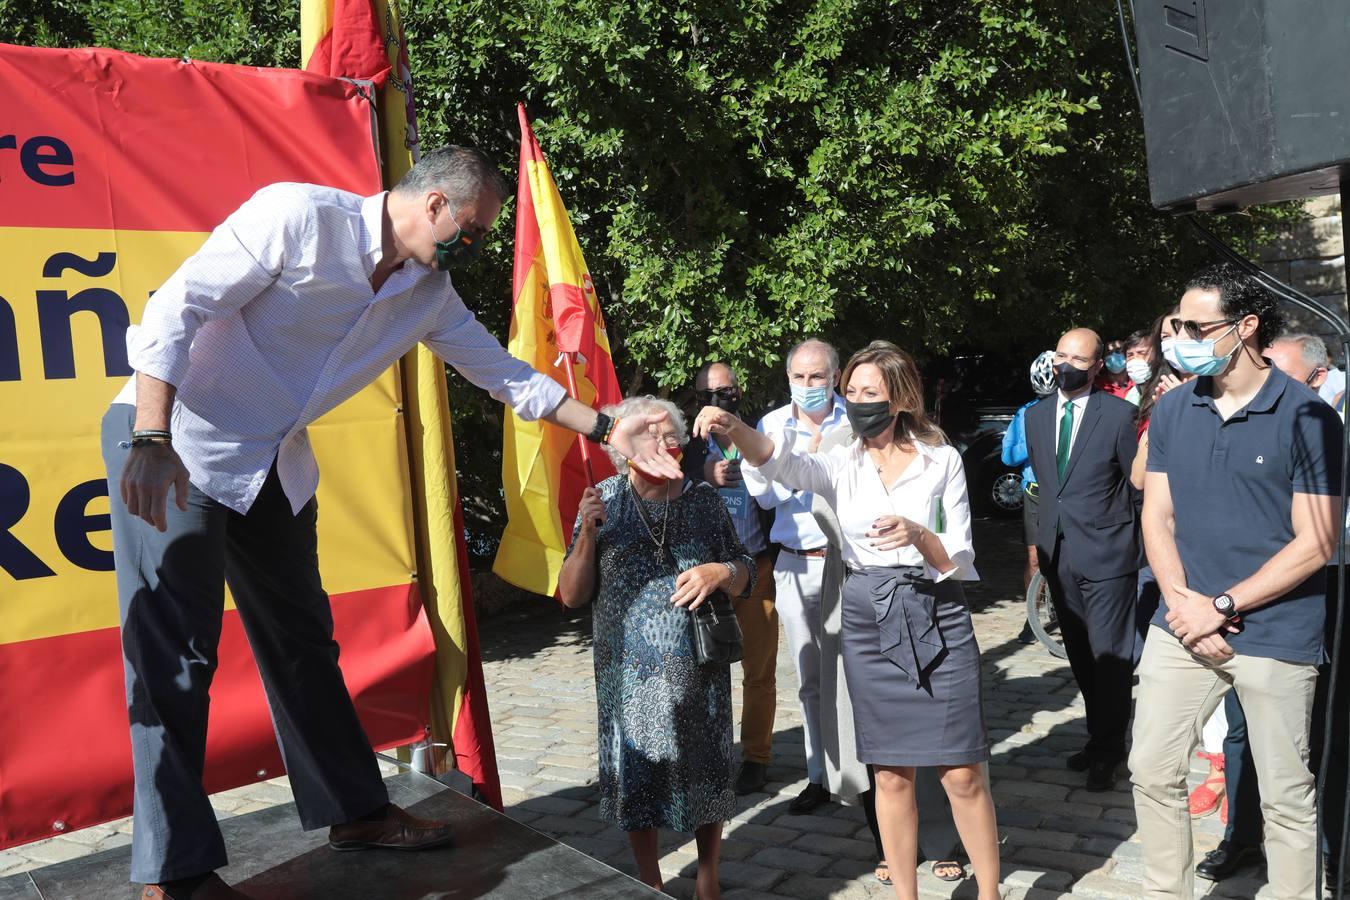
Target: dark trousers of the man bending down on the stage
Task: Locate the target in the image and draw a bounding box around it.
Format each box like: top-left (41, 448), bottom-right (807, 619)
top-left (103, 405), bottom-right (389, 884)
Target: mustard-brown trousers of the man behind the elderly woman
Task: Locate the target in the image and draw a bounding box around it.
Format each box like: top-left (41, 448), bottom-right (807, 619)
top-left (736, 553), bottom-right (778, 765)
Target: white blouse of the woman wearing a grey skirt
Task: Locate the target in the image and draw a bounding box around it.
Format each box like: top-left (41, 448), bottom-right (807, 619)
top-left (743, 432), bottom-right (980, 582)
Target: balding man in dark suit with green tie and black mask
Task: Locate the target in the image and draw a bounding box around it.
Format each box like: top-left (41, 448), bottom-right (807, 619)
top-left (1026, 328), bottom-right (1142, 791)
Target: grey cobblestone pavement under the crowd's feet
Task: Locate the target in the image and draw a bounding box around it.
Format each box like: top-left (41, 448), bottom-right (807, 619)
top-left (0, 512), bottom-right (1262, 900)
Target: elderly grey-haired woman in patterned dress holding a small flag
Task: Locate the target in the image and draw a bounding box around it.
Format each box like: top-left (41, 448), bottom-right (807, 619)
top-left (559, 397), bottom-right (755, 900)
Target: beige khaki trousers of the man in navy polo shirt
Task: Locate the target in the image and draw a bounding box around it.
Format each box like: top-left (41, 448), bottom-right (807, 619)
top-left (1130, 626), bottom-right (1318, 900)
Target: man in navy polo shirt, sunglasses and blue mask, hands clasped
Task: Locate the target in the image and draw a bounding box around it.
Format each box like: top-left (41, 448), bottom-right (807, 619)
top-left (1130, 264), bottom-right (1342, 900)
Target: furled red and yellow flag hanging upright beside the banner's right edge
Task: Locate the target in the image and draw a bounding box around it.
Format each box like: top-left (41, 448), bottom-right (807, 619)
top-left (301, 0), bottom-right (502, 810)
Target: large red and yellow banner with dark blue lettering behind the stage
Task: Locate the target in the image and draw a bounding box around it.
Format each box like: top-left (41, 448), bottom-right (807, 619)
top-left (0, 45), bottom-right (432, 847)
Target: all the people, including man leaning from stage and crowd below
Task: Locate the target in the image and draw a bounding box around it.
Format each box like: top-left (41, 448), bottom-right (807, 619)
top-left (101, 138), bottom-right (1350, 900)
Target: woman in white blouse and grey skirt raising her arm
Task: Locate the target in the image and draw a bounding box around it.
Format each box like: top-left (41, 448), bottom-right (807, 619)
top-left (694, 341), bottom-right (999, 900)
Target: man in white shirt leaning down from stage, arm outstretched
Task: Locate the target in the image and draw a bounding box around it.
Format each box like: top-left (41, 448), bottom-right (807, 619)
top-left (103, 147), bottom-right (679, 900)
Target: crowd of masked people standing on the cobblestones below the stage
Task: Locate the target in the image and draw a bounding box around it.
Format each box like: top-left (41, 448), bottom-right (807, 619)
top-left (562, 264), bottom-right (1350, 900)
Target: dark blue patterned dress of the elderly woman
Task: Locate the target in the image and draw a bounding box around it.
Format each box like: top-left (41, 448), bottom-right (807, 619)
top-left (568, 475), bottom-right (755, 831)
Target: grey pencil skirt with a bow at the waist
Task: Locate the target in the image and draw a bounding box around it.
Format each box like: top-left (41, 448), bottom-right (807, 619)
top-left (841, 567), bottom-right (990, 766)
